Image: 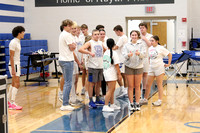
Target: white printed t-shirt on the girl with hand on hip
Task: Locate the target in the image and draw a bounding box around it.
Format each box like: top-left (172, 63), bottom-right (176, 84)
top-left (149, 45), bottom-right (169, 69)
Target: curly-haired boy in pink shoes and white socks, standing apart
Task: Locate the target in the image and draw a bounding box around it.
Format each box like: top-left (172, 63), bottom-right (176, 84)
top-left (8, 26), bottom-right (25, 110)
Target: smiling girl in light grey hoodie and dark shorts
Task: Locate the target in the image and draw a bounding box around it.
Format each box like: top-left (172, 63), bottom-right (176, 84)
top-left (123, 30), bottom-right (146, 111)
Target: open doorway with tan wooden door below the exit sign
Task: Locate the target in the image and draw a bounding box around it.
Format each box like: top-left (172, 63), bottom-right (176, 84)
top-left (126, 17), bottom-right (176, 52)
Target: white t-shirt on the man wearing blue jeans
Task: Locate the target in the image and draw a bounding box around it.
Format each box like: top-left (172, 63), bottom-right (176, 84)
top-left (59, 30), bottom-right (74, 61)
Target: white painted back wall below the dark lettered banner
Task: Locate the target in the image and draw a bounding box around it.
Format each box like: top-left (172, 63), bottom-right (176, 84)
top-left (24, 0), bottom-right (190, 72)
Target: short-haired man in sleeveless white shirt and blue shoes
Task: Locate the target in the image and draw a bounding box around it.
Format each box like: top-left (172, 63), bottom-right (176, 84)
top-left (79, 29), bottom-right (105, 108)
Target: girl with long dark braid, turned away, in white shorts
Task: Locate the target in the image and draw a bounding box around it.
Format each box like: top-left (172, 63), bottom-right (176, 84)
top-left (102, 38), bottom-right (122, 112)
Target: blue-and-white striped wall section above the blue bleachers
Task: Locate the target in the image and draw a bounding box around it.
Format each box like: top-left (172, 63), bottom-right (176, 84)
top-left (0, 0), bottom-right (25, 33)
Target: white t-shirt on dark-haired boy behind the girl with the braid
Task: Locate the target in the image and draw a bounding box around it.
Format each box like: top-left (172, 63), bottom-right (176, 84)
top-left (116, 35), bottom-right (128, 63)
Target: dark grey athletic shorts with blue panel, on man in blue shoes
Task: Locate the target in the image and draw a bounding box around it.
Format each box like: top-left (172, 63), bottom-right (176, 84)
top-left (88, 68), bottom-right (103, 83)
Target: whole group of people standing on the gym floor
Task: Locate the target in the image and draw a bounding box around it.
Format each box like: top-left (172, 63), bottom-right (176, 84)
top-left (8, 19), bottom-right (172, 112)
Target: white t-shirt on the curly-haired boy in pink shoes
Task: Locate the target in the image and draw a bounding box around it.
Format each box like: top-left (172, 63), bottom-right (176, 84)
top-left (9, 38), bottom-right (21, 64)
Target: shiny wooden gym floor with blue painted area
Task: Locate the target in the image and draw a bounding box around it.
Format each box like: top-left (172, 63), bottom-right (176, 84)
top-left (8, 77), bottom-right (200, 133)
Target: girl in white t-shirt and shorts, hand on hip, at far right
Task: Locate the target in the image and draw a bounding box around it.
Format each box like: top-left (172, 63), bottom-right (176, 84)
top-left (140, 36), bottom-right (172, 106)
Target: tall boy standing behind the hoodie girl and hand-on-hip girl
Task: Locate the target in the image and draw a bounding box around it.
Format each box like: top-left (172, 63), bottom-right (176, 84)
top-left (139, 23), bottom-right (153, 95)
